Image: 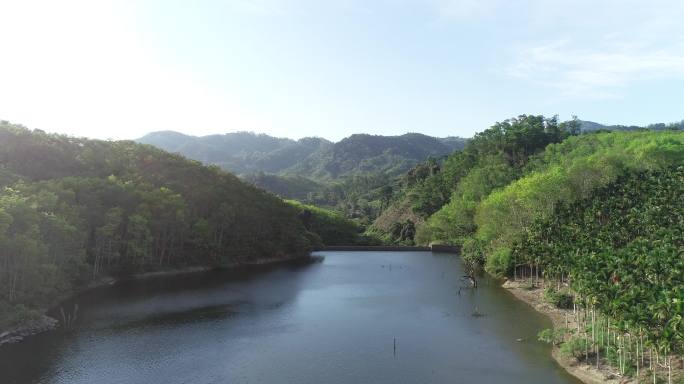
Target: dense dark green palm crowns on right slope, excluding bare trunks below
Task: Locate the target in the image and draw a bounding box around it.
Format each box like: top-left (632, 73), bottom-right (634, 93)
top-left (515, 167), bottom-right (684, 360)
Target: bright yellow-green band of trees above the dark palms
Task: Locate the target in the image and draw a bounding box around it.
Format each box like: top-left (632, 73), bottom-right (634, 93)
top-left (475, 131), bottom-right (684, 268)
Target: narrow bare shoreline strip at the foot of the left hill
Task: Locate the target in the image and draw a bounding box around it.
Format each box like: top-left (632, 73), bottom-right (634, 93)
top-left (0, 254), bottom-right (321, 348)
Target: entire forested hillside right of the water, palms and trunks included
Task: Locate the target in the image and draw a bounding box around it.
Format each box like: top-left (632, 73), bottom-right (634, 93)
top-left (371, 116), bottom-right (684, 382)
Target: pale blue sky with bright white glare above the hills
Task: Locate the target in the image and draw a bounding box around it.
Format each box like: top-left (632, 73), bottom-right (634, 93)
top-left (0, 0), bottom-right (684, 140)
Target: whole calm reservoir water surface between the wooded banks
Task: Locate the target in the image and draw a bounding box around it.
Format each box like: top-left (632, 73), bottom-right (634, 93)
top-left (0, 252), bottom-right (576, 384)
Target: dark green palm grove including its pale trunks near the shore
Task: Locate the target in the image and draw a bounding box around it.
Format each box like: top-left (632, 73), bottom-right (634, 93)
top-left (511, 166), bottom-right (684, 376)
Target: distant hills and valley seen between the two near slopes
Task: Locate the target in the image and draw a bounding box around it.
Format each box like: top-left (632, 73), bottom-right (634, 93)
top-left (139, 132), bottom-right (466, 242)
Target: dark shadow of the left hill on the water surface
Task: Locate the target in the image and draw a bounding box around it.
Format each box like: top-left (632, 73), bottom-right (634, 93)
top-left (0, 259), bottom-right (320, 384)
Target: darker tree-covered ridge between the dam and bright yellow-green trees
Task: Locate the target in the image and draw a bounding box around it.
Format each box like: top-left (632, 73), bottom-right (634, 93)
top-left (373, 116), bottom-right (580, 245)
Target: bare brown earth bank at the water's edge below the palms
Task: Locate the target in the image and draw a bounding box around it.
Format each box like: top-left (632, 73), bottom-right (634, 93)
top-left (502, 280), bottom-right (636, 384)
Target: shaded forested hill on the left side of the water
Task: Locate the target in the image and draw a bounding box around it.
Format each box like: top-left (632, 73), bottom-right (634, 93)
top-left (0, 122), bottom-right (311, 329)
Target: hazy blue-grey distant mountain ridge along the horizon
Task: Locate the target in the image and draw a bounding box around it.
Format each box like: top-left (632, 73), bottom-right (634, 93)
top-left (137, 131), bottom-right (466, 181)
